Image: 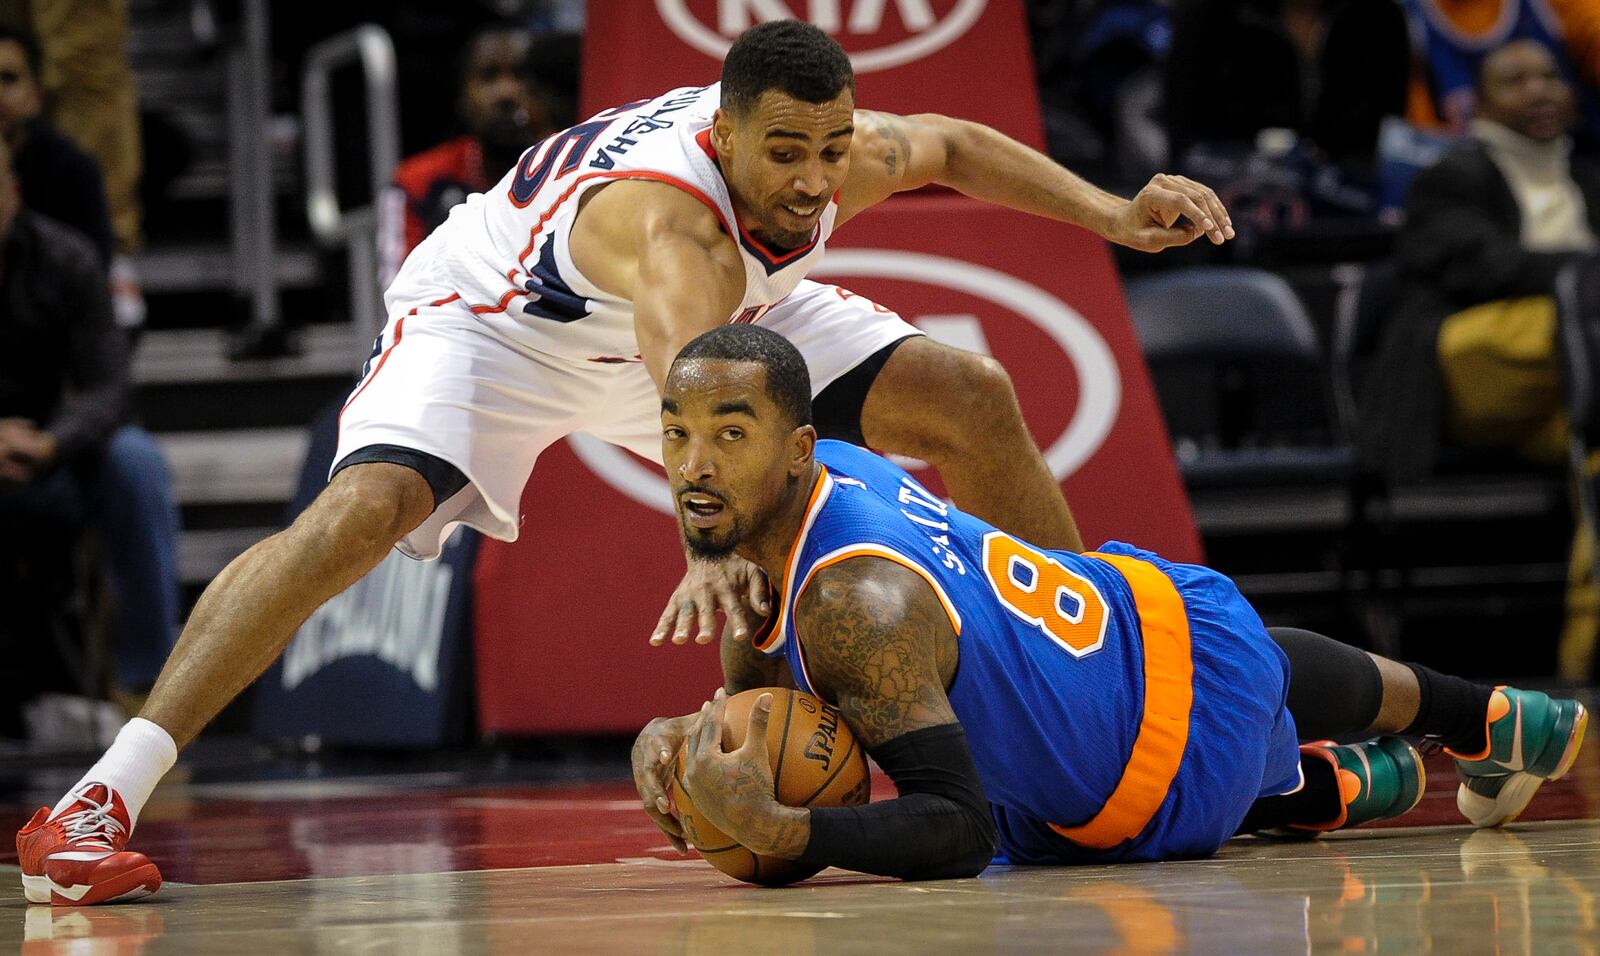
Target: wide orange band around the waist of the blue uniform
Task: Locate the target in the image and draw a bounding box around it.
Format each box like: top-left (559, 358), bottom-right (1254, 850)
top-left (1050, 552), bottom-right (1194, 849)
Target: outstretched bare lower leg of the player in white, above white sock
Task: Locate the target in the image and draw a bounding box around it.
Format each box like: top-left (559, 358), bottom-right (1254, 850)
top-left (139, 462), bottom-right (434, 747)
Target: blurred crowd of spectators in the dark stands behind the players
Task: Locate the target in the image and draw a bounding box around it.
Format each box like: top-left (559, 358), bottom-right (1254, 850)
top-left (0, 0), bottom-right (1600, 737)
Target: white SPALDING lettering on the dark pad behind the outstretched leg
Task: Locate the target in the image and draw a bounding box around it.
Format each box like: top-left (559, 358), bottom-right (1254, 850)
top-left (283, 552), bottom-right (456, 692)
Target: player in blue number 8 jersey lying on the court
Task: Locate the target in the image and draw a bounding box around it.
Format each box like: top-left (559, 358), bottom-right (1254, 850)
top-left (634, 326), bottom-right (1587, 879)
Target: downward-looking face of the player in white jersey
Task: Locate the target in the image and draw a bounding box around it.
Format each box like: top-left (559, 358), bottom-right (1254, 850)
top-left (712, 88), bottom-right (856, 249)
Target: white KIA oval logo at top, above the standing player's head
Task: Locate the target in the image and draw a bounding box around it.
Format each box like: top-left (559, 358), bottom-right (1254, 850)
top-left (656, 0), bottom-right (989, 74)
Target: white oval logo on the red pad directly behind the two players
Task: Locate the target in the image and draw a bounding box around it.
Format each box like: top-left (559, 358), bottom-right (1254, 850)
top-left (568, 249), bottom-right (1122, 515)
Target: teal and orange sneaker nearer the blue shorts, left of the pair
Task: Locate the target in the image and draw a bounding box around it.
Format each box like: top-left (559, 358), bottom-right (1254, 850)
top-left (1290, 737), bottom-right (1427, 833)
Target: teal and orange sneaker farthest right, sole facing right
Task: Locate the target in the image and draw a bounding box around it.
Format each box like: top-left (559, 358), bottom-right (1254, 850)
top-left (1446, 687), bottom-right (1589, 827)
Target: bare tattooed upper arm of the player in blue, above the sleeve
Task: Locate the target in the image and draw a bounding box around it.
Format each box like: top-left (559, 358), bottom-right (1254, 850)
top-left (797, 558), bottom-right (955, 748)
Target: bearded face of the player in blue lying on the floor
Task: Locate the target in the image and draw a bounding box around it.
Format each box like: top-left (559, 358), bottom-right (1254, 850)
top-left (661, 358), bottom-right (811, 556)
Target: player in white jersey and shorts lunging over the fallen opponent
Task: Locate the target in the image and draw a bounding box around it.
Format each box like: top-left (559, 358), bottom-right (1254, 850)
top-left (18, 21), bottom-right (1232, 905)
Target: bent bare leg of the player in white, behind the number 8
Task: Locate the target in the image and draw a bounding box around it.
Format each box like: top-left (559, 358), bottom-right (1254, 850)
top-left (861, 337), bottom-right (1083, 552)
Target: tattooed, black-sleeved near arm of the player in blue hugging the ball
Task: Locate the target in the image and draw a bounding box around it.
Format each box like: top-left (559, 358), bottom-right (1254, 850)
top-left (685, 558), bottom-right (997, 879)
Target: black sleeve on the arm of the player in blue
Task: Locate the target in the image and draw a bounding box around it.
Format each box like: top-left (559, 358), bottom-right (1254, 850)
top-left (800, 724), bottom-right (1000, 879)
